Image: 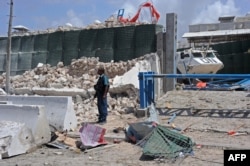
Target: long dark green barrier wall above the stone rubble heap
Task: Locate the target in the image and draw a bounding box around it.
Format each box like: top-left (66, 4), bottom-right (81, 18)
top-left (0, 24), bottom-right (162, 74)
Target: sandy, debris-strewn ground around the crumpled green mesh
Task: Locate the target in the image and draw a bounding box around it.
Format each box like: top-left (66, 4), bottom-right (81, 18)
top-left (0, 91), bottom-right (250, 166)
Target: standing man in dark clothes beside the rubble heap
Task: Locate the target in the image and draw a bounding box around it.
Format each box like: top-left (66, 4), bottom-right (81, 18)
top-left (94, 67), bottom-right (109, 123)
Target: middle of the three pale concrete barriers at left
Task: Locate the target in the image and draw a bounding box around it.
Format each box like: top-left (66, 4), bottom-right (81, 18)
top-left (0, 104), bottom-right (51, 145)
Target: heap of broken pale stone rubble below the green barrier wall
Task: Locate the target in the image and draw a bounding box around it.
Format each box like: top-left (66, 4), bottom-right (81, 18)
top-left (0, 54), bottom-right (155, 126)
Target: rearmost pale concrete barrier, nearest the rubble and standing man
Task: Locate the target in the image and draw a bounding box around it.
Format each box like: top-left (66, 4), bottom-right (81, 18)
top-left (0, 95), bottom-right (77, 131)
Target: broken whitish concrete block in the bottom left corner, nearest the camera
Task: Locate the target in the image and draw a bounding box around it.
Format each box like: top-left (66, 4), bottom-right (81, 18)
top-left (0, 121), bottom-right (37, 158)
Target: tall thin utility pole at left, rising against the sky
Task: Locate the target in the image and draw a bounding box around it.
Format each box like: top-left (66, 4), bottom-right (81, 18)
top-left (5, 0), bottom-right (13, 94)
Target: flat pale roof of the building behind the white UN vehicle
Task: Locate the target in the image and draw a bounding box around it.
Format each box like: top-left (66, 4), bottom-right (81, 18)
top-left (182, 13), bottom-right (250, 43)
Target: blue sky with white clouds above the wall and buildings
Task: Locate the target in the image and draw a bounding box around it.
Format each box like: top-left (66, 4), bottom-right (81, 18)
top-left (0, 0), bottom-right (250, 39)
